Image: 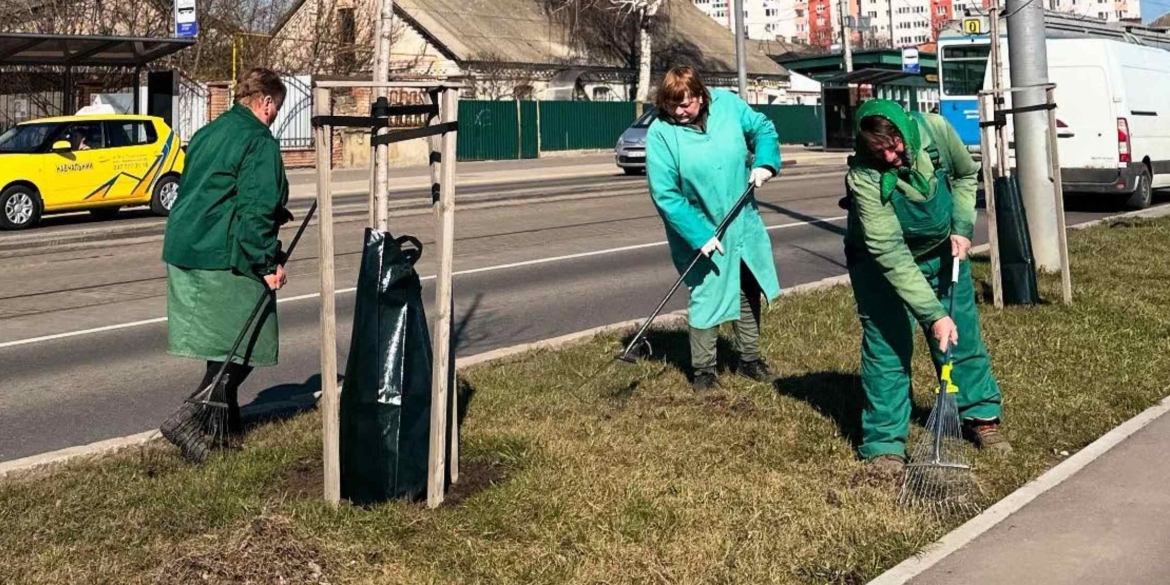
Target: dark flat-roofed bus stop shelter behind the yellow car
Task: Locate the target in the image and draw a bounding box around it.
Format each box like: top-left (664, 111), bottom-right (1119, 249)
top-left (0, 33), bottom-right (195, 130)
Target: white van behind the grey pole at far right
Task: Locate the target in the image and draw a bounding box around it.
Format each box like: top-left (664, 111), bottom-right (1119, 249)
top-left (984, 39), bottom-right (1170, 208)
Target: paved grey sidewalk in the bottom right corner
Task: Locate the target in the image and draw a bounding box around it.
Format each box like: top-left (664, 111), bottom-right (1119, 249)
top-left (907, 404), bottom-right (1170, 585)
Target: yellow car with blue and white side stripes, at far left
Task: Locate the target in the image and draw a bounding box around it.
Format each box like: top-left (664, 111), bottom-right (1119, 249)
top-left (0, 113), bottom-right (185, 229)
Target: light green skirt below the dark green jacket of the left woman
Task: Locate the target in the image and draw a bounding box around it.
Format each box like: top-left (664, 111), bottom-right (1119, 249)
top-left (166, 264), bottom-right (280, 366)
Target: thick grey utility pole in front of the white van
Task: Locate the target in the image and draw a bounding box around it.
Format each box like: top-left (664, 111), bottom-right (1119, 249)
top-left (1006, 0), bottom-right (1060, 267)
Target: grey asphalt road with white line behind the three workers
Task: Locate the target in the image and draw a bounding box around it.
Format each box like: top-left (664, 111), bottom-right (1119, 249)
top-left (0, 168), bottom-right (1151, 461)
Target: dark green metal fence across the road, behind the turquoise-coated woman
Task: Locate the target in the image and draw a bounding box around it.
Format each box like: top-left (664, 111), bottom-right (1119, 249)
top-left (459, 99), bottom-right (824, 160)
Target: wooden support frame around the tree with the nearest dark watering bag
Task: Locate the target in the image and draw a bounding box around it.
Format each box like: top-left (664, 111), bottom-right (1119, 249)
top-left (312, 80), bottom-right (463, 508)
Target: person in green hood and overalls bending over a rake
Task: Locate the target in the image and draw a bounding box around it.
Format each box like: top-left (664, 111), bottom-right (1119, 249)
top-left (845, 99), bottom-right (1011, 473)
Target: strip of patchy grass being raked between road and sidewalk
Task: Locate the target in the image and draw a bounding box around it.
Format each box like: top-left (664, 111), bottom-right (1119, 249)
top-left (0, 219), bottom-right (1170, 585)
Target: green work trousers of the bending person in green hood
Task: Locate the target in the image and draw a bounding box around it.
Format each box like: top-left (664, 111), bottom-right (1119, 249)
top-left (849, 249), bottom-right (1000, 459)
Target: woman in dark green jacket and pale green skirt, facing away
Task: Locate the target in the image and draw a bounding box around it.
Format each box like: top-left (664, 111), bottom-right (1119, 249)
top-left (163, 69), bottom-right (291, 433)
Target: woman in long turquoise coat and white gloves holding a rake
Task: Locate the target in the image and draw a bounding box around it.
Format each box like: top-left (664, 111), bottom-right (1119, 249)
top-left (646, 67), bottom-right (780, 391)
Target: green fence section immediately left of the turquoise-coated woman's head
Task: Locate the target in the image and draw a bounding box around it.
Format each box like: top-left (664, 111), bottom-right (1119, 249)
top-left (541, 102), bottom-right (635, 151)
